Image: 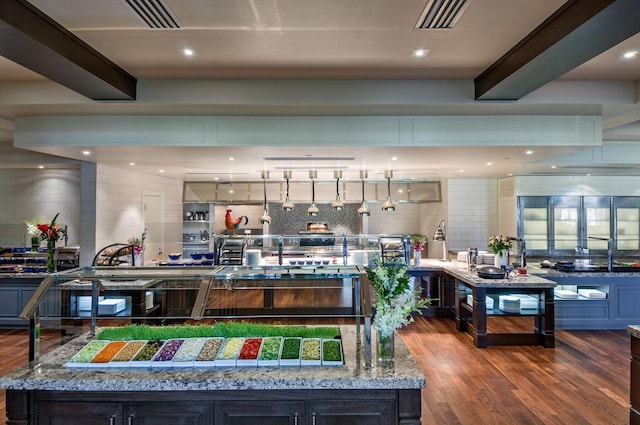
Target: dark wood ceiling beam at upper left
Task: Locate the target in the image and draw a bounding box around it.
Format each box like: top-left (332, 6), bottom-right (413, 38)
top-left (0, 0), bottom-right (137, 100)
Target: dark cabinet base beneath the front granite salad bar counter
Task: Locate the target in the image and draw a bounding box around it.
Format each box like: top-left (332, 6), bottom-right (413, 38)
top-left (7, 389), bottom-right (421, 425)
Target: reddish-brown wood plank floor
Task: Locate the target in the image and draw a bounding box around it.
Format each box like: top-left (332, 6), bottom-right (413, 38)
top-left (0, 318), bottom-right (630, 425)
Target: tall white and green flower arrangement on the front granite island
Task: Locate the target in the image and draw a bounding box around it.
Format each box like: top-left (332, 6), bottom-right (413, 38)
top-left (365, 257), bottom-right (431, 357)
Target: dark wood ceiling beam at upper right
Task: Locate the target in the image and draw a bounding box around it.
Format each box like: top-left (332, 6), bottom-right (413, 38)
top-left (474, 0), bottom-right (640, 100)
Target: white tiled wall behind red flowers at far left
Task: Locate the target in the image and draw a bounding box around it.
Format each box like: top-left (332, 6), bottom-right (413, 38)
top-left (0, 168), bottom-right (80, 247)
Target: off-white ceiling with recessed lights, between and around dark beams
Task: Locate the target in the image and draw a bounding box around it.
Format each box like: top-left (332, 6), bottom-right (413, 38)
top-left (0, 0), bottom-right (640, 180)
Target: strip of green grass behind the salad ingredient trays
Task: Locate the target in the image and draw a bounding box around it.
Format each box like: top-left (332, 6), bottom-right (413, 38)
top-left (96, 322), bottom-right (340, 341)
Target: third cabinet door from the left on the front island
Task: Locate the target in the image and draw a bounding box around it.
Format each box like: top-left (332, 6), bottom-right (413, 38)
top-left (216, 400), bottom-right (305, 425)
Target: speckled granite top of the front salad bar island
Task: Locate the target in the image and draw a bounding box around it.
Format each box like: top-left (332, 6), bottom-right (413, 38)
top-left (0, 326), bottom-right (425, 391)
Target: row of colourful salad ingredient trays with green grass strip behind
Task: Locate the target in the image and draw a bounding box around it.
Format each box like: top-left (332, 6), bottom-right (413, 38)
top-left (65, 323), bottom-right (344, 369)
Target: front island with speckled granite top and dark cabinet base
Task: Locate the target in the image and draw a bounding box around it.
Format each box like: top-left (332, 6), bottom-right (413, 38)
top-left (0, 326), bottom-right (425, 425)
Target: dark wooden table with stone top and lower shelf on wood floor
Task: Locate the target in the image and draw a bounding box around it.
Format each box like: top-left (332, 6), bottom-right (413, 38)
top-left (446, 268), bottom-right (556, 348)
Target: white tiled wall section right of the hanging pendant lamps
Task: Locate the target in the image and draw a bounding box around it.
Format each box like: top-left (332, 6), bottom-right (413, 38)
top-left (447, 179), bottom-right (498, 251)
